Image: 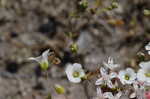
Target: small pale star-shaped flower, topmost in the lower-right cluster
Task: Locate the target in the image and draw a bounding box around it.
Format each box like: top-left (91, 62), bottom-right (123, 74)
top-left (103, 57), bottom-right (119, 70)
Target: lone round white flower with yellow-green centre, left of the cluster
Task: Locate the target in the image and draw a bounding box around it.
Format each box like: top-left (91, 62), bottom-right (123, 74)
top-left (65, 63), bottom-right (85, 83)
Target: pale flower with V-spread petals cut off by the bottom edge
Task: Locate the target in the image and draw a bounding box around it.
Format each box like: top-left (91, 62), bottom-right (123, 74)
top-left (104, 91), bottom-right (122, 99)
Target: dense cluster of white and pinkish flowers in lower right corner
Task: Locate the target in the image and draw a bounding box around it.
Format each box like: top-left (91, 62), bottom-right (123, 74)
top-left (95, 55), bottom-right (150, 99)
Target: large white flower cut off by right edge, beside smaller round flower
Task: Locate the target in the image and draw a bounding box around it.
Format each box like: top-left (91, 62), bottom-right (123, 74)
top-left (137, 61), bottom-right (150, 84)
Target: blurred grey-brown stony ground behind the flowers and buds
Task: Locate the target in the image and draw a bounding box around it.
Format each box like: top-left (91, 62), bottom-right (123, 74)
top-left (0, 0), bottom-right (150, 99)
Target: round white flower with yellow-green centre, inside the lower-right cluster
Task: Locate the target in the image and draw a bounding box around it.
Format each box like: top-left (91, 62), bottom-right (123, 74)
top-left (118, 68), bottom-right (136, 84)
